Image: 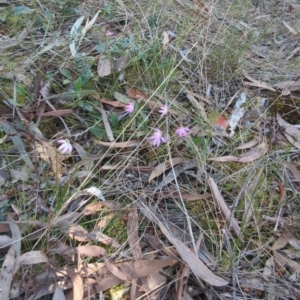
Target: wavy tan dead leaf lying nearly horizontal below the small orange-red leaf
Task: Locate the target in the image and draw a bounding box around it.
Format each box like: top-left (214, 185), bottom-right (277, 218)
top-left (208, 143), bottom-right (268, 163)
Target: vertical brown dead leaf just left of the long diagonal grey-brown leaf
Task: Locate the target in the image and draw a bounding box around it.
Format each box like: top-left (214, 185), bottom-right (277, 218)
top-left (127, 205), bottom-right (143, 259)
